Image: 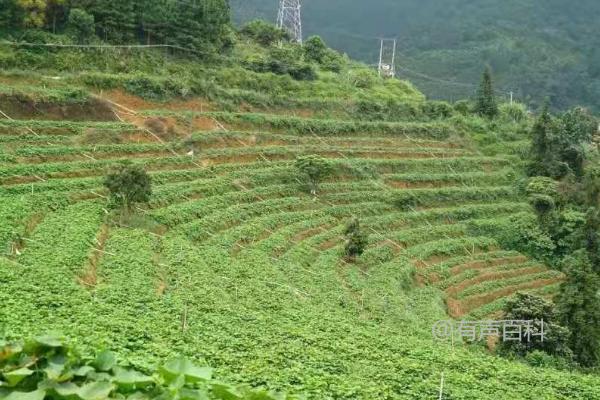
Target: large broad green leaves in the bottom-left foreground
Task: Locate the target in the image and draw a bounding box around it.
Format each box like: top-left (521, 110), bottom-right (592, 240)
top-left (0, 335), bottom-right (299, 400)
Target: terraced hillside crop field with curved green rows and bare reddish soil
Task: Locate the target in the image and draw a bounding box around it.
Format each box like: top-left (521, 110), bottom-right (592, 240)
top-left (0, 88), bottom-right (600, 399)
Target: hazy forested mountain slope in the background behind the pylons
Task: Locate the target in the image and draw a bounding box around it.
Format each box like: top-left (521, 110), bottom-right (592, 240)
top-left (231, 0), bottom-right (600, 110)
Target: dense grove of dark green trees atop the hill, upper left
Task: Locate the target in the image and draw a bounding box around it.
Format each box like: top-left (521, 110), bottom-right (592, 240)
top-left (0, 0), bottom-right (232, 55)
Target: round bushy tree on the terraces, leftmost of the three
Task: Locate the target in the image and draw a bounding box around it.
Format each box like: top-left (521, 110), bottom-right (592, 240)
top-left (104, 164), bottom-right (152, 215)
